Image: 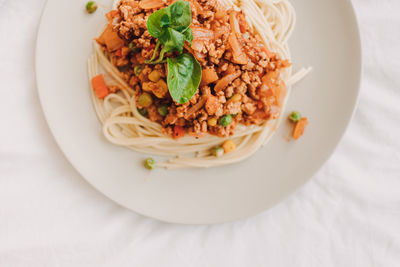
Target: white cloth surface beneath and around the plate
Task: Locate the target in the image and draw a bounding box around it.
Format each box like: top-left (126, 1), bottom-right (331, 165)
top-left (0, 0), bottom-right (400, 267)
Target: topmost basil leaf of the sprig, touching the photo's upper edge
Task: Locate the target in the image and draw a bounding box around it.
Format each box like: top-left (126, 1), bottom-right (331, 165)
top-left (167, 1), bottom-right (192, 32)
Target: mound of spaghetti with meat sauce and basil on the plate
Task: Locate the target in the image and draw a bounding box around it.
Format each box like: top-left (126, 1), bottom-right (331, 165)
top-left (89, 0), bottom-right (309, 168)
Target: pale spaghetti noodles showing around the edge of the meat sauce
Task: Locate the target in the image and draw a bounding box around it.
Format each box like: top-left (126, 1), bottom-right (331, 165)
top-left (88, 0), bottom-right (310, 169)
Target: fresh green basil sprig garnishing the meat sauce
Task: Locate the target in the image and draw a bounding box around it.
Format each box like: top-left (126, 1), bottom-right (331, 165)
top-left (146, 1), bottom-right (201, 104)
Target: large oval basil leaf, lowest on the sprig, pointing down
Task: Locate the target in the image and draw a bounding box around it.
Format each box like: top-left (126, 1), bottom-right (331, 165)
top-left (167, 53), bottom-right (201, 104)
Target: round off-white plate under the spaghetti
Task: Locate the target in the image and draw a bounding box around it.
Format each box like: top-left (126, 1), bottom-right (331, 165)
top-left (36, 0), bottom-right (361, 224)
